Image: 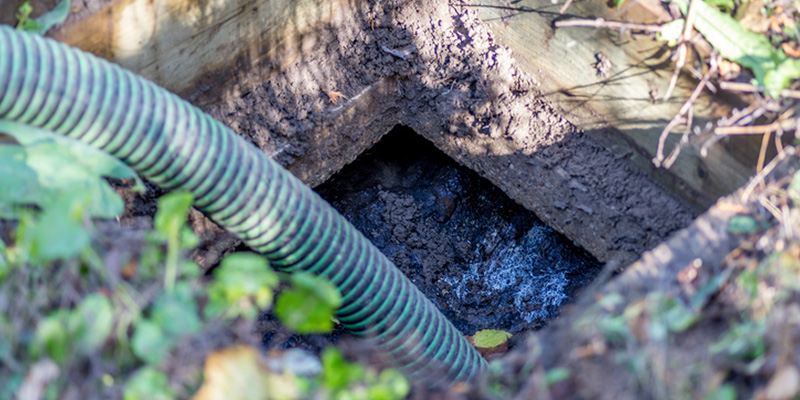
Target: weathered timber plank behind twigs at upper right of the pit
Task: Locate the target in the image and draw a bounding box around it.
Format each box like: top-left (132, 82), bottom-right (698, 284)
top-left (473, 0), bottom-right (759, 210)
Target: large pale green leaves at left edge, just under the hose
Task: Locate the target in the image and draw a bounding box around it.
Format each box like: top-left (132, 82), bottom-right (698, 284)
top-left (0, 121), bottom-right (141, 263)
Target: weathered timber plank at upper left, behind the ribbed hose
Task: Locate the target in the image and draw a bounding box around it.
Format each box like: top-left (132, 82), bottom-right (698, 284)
top-left (42, 0), bottom-right (347, 103)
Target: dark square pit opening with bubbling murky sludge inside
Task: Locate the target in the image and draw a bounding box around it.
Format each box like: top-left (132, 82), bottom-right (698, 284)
top-left (316, 126), bottom-right (599, 334)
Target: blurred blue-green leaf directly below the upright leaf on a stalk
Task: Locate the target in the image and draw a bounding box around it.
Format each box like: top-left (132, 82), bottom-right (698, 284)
top-left (151, 282), bottom-right (202, 337)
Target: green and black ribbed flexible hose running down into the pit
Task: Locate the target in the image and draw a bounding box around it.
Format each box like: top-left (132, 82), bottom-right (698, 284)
top-left (0, 26), bottom-right (486, 383)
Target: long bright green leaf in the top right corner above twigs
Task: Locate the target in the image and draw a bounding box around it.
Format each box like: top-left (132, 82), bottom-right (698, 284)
top-left (672, 0), bottom-right (800, 97)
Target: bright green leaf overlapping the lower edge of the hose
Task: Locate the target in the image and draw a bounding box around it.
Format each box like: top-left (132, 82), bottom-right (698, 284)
top-left (275, 273), bottom-right (342, 334)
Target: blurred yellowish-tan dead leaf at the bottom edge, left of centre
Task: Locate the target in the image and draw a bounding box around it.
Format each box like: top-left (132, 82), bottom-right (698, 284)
top-left (193, 345), bottom-right (300, 400)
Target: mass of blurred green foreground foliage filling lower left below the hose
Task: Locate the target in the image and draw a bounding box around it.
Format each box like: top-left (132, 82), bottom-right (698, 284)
top-left (0, 122), bottom-right (388, 400)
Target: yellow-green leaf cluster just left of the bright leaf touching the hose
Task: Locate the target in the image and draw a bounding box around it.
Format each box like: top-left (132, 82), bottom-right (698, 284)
top-left (205, 253), bottom-right (278, 319)
